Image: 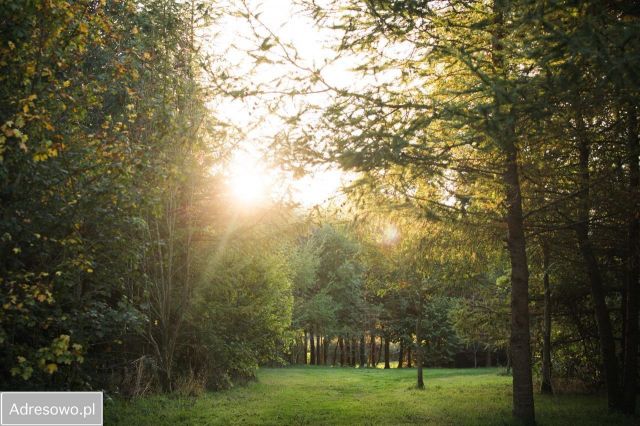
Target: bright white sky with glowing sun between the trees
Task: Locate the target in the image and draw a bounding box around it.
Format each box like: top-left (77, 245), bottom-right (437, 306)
top-left (204, 0), bottom-right (354, 208)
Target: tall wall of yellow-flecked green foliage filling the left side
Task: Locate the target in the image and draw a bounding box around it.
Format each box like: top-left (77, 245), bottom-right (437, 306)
top-left (0, 0), bottom-right (290, 394)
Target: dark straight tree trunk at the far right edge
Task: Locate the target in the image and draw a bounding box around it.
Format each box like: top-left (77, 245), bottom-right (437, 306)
top-left (622, 104), bottom-right (640, 414)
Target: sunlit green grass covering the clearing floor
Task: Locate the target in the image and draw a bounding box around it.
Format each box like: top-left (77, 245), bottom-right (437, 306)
top-left (105, 367), bottom-right (640, 426)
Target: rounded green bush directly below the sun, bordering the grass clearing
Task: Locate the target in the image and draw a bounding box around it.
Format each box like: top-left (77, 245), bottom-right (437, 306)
top-left (189, 242), bottom-right (293, 388)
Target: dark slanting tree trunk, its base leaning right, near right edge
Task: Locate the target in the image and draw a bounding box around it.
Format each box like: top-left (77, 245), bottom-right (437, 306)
top-left (575, 126), bottom-right (621, 410)
